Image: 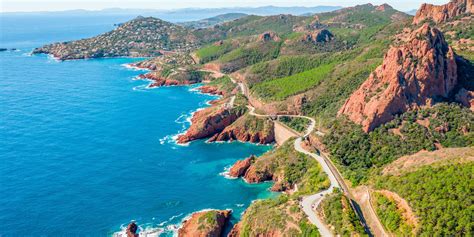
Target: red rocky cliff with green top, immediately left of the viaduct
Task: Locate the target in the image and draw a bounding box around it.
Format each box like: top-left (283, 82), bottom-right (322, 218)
top-left (209, 115), bottom-right (275, 144)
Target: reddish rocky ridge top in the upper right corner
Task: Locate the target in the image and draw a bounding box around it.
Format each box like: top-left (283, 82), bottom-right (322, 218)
top-left (413, 0), bottom-right (474, 24)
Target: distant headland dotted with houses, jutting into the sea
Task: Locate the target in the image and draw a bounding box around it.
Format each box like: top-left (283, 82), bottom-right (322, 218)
top-left (33, 17), bottom-right (200, 60)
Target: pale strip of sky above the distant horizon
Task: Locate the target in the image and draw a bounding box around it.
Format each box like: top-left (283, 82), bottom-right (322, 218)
top-left (0, 0), bottom-right (448, 12)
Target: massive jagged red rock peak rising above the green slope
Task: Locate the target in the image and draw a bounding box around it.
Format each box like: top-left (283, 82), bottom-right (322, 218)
top-left (339, 24), bottom-right (457, 132)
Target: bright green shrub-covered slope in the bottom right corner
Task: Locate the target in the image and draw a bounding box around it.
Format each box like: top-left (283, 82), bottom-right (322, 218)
top-left (375, 162), bottom-right (474, 236)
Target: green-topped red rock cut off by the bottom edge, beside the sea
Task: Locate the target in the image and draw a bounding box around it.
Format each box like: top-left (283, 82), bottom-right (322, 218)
top-left (178, 210), bottom-right (231, 237)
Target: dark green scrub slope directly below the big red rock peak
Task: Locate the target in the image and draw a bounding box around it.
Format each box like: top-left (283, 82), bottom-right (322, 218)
top-left (323, 104), bottom-right (474, 184)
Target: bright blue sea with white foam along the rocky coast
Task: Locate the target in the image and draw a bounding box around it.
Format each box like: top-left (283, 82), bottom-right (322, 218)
top-left (0, 16), bottom-right (274, 236)
